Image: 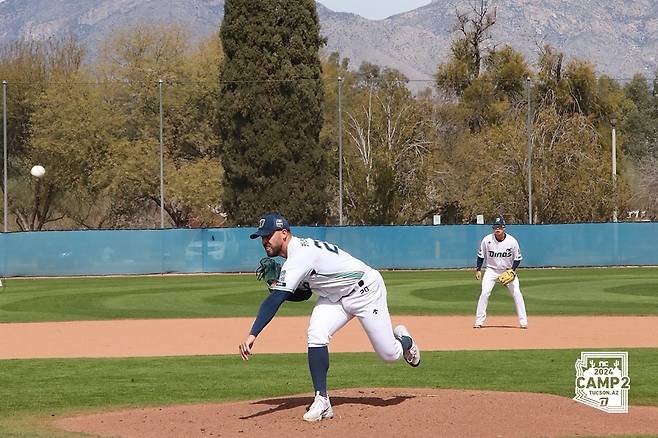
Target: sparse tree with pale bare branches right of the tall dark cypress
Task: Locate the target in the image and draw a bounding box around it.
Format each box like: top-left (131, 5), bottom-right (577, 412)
top-left (336, 64), bottom-right (437, 224)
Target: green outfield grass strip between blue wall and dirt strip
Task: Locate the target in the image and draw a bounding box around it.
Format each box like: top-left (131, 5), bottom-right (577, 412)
top-left (0, 268), bottom-right (658, 322)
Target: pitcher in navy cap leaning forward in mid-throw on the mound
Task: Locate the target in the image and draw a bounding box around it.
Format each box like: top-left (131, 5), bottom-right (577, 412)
top-left (239, 213), bottom-right (420, 421)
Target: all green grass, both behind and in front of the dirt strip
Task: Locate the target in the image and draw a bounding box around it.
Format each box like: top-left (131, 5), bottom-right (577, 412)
top-left (0, 268), bottom-right (658, 437)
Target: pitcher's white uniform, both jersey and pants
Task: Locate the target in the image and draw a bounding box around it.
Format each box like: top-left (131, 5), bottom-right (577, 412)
top-left (272, 236), bottom-right (403, 362)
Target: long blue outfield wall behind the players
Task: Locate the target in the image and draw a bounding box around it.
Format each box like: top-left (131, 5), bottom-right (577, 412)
top-left (0, 222), bottom-right (658, 277)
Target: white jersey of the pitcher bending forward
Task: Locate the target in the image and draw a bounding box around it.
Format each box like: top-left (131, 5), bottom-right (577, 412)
top-left (272, 236), bottom-right (372, 302)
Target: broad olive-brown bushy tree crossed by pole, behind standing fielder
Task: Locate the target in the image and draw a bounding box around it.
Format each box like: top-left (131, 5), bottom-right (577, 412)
top-left (452, 107), bottom-right (628, 223)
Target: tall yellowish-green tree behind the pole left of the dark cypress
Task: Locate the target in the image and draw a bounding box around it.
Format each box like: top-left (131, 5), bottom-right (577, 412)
top-left (93, 24), bottom-right (193, 227)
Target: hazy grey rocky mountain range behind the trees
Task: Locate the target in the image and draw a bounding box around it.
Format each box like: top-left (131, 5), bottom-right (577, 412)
top-left (0, 0), bottom-right (658, 83)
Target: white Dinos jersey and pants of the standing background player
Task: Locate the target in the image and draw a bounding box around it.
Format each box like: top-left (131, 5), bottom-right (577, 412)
top-left (475, 233), bottom-right (528, 326)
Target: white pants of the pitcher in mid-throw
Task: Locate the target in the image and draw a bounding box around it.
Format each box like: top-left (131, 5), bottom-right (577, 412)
top-left (308, 269), bottom-right (402, 362)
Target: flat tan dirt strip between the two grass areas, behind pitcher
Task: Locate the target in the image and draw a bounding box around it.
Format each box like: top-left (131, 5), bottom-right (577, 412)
top-left (0, 316), bottom-right (658, 359)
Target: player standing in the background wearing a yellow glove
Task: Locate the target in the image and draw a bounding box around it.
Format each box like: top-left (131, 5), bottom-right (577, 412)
top-left (473, 217), bottom-right (528, 329)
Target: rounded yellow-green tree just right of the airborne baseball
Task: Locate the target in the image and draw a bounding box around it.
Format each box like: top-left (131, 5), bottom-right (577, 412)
top-left (26, 71), bottom-right (120, 229)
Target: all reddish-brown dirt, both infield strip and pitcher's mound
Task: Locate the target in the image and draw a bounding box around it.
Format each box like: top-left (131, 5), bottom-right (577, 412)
top-left (0, 316), bottom-right (658, 438)
